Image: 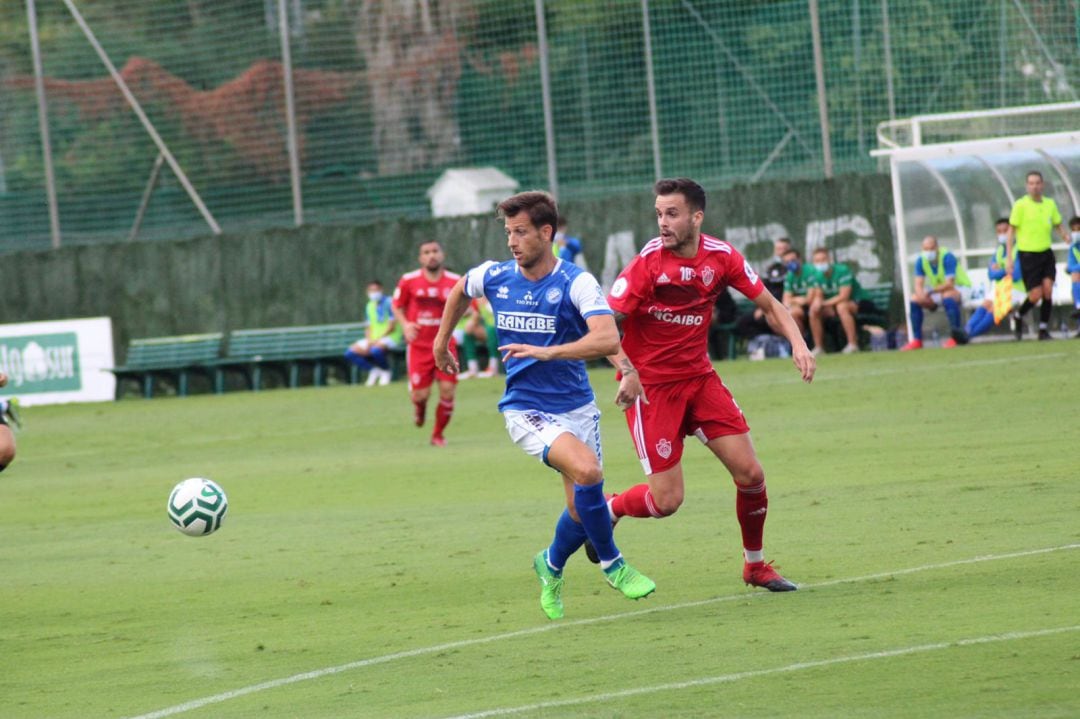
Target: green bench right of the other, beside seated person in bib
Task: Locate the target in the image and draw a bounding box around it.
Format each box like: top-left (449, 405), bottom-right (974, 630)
top-left (214, 323), bottom-right (366, 393)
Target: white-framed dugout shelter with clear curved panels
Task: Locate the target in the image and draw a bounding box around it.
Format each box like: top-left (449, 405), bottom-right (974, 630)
top-left (870, 101), bottom-right (1080, 333)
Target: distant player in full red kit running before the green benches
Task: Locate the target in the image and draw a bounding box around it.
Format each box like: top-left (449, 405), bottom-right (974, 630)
top-left (393, 240), bottom-right (460, 447)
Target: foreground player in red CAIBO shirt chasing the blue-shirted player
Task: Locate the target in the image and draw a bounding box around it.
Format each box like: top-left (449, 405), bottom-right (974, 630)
top-left (604, 178), bottom-right (814, 592)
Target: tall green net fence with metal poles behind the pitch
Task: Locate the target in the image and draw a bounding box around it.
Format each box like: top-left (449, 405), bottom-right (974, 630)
top-left (0, 0), bottom-right (1080, 250)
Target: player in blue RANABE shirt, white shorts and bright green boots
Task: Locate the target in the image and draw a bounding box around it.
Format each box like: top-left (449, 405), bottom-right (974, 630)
top-left (434, 192), bottom-right (657, 619)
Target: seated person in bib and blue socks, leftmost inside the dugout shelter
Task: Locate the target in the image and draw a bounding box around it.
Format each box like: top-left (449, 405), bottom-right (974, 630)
top-left (900, 234), bottom-right (971, 352)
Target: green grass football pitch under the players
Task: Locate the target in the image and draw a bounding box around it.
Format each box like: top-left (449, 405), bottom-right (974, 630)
top-left (0, 340), bottom-right (1080, 719)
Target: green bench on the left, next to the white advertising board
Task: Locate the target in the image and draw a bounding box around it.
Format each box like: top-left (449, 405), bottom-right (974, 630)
top-left (109, 333), bottom-right (225, 399)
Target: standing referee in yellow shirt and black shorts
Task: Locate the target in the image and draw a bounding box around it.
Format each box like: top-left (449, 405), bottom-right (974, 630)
top-left (1005, 169), bottom-right (1069, 340)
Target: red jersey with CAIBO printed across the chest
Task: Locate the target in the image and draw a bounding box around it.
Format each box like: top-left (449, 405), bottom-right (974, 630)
top-left (608, 234), bottom-right (765, 384)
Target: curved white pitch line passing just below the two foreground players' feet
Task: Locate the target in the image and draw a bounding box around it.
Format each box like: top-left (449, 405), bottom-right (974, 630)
top-left (124, 544), bottom-right (1080, 719)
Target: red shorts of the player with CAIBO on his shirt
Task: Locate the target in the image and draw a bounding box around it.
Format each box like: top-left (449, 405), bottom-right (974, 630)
top-left (625, 372), bottom-right (750, 475)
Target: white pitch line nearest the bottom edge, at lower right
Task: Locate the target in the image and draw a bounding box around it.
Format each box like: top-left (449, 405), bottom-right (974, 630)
top-left (438, 624), bottom-right (1080, 719)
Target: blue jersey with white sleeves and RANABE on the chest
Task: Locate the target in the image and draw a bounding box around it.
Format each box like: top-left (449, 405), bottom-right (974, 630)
top-left (465, 260), bottom-right (612, 413)
